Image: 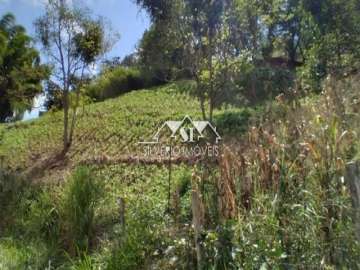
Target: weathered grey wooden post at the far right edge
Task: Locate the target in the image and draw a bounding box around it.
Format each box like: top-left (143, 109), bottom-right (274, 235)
top-left (345, 161), bottom-right (360, 241)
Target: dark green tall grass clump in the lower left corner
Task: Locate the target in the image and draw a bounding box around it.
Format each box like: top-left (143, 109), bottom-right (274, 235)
top-left (0, 167), bottom-right (104, 268)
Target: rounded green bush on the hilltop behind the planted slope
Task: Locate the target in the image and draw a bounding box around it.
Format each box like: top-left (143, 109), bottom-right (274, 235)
top-left (86, 66), bottom-right (145, 101)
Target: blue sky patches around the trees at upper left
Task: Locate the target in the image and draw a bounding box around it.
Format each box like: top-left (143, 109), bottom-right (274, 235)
top-left (0, 0), bottom-right (150, 120)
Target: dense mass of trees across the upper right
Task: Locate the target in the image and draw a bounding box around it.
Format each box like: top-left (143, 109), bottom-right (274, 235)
top-left (136, 0), bottom-right (360, 110)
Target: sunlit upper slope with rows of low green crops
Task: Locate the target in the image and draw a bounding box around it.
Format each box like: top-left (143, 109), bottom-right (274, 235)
top-left (0, 83), bottom-right (199, 172)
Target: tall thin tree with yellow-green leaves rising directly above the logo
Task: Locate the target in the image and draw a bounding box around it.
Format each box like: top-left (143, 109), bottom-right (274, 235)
top-left (176, 0), bottom-right (249, 121)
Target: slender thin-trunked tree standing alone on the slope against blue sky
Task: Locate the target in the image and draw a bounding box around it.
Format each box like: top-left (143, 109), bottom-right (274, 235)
top-left (35, 0), bottom-right (115, 152)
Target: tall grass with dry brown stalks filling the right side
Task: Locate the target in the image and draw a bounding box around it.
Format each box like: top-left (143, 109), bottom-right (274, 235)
top-left (215, 74), bottom-right (360, 269)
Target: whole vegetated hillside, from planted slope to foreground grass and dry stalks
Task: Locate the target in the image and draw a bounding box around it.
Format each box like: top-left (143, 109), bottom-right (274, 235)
top-left (0, 77), bottom-right (360, 270)
